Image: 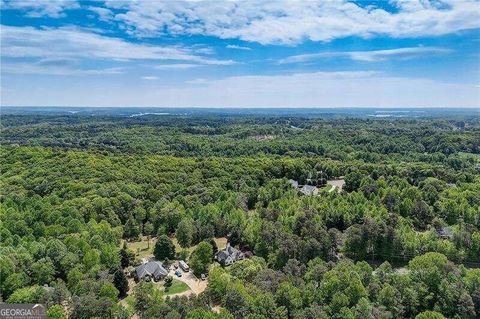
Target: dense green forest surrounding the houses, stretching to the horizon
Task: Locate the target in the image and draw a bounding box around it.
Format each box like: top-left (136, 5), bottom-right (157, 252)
top-left (0, 110), bottom-right (480, 319)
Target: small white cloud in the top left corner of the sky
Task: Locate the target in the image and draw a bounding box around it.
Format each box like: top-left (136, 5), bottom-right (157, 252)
top-left (1, 0), bottom-right (80, 18)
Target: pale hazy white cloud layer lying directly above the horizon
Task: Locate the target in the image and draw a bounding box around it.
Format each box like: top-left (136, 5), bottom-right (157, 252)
top-left (2, 72), bottom-right (480, 108)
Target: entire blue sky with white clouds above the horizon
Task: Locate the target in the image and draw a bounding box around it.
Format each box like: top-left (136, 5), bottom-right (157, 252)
top-left (0, 0), bottom-right (480, 108)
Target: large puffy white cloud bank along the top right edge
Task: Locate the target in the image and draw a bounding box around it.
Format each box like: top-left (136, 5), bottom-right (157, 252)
top-left (102, 0), bottom-right (480, 44)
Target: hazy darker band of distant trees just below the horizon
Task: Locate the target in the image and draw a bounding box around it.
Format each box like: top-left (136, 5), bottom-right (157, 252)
top-left (1, 115), bottom-right (480, 162)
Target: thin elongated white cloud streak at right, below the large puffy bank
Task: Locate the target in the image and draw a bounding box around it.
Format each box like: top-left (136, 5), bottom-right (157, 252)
top-left (278, 47), bottom-right (453, 64)
